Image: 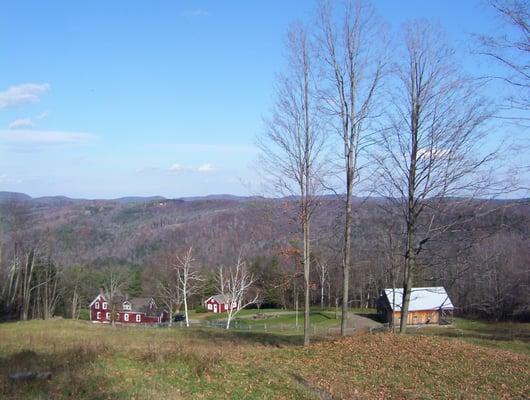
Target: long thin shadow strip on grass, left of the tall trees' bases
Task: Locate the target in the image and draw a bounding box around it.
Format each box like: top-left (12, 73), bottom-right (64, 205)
top-left (189, 329), bottom-right (304, 346)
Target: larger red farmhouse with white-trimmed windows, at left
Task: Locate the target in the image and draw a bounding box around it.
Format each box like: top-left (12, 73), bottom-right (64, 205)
top-left (90, 294), bottom-right (169, 324)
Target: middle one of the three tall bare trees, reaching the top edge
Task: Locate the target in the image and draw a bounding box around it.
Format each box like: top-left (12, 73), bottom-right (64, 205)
top-left (317, 0), bottom-right (387, 335)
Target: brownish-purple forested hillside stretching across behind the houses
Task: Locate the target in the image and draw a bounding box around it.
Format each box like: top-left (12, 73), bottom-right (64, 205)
top-left (0, 193), bottom-right (530, 319)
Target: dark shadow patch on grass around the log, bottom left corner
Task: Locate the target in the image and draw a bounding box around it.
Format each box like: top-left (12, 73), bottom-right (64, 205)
top-left (0, 346), bottom-right (115, 399)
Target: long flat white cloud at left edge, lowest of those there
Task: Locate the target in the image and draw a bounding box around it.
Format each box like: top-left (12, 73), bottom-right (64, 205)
top-left (0, 129), bottom-right (95, 148)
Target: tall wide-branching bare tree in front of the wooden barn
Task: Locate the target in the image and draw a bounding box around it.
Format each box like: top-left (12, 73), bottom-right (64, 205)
top-left (375, 22), bottom-right (497, 332)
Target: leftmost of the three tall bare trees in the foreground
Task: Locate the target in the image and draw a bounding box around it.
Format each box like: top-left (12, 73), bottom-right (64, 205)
top-left (258, 25), bottom-right (324, 344)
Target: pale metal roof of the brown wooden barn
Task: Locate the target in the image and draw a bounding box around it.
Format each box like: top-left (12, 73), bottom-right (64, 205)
top-left (385, 286), bottom-right (453, 311)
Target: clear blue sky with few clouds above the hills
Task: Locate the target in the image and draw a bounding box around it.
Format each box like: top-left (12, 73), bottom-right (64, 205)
top-left (0, 0), bottom-right (520, 198)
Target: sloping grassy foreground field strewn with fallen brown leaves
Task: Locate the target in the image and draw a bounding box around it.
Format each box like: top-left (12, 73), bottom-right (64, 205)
top-left (0, 319), bottom-right (530, 399)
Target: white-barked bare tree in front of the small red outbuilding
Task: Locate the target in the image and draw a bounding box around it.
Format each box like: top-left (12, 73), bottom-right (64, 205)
top-left (224, 255), bottom-right (259, 329)
